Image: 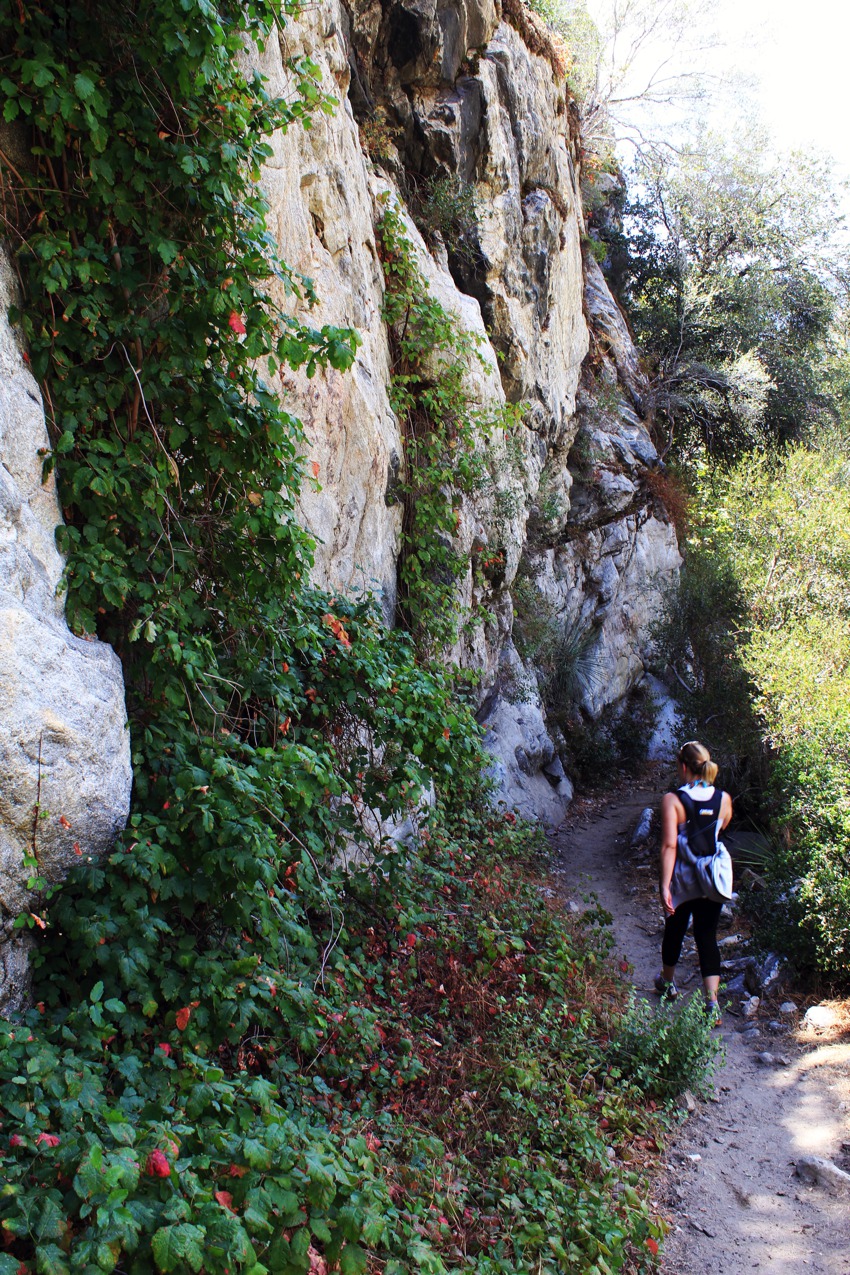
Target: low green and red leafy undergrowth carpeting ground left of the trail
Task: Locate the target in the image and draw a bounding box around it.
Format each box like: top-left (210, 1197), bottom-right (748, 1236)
top-left (0, 811), bottom-right (663, 1275)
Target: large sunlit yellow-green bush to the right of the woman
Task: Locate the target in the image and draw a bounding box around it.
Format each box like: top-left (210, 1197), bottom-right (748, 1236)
top-left (674, 446), bottom-right (850, 980)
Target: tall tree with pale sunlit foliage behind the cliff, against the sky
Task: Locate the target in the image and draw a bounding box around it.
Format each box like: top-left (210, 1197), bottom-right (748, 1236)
top-left (609, 129), bottom-right (846, 454)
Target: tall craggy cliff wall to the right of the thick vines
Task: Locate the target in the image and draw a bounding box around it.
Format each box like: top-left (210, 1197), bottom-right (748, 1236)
top-left (263, 0), bottom-right (679, 824)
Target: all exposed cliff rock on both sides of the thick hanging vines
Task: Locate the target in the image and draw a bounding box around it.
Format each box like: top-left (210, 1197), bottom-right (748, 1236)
top-left (0, 0), bottom-right (678, 1014)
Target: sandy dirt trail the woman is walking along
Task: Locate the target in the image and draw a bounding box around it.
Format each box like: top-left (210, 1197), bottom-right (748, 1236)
top-left (556, 788), bottom-right (850, 1275)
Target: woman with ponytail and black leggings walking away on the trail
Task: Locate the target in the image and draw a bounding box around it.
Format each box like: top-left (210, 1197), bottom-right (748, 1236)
top-left (655, 740), bottom-right (731, 1025)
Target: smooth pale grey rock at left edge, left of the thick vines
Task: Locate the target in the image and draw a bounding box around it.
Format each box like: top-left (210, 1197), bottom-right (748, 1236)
top-left (0, 251), bottom-right (131, 1016)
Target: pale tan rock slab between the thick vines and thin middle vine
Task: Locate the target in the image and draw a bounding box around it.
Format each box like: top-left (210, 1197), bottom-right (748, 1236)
top-left (259, 8), bottom-right (403, 618)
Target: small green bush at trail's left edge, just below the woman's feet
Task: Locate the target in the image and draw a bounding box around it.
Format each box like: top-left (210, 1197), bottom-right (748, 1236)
top-left (613, 993), bottom-right (723, 1098)
